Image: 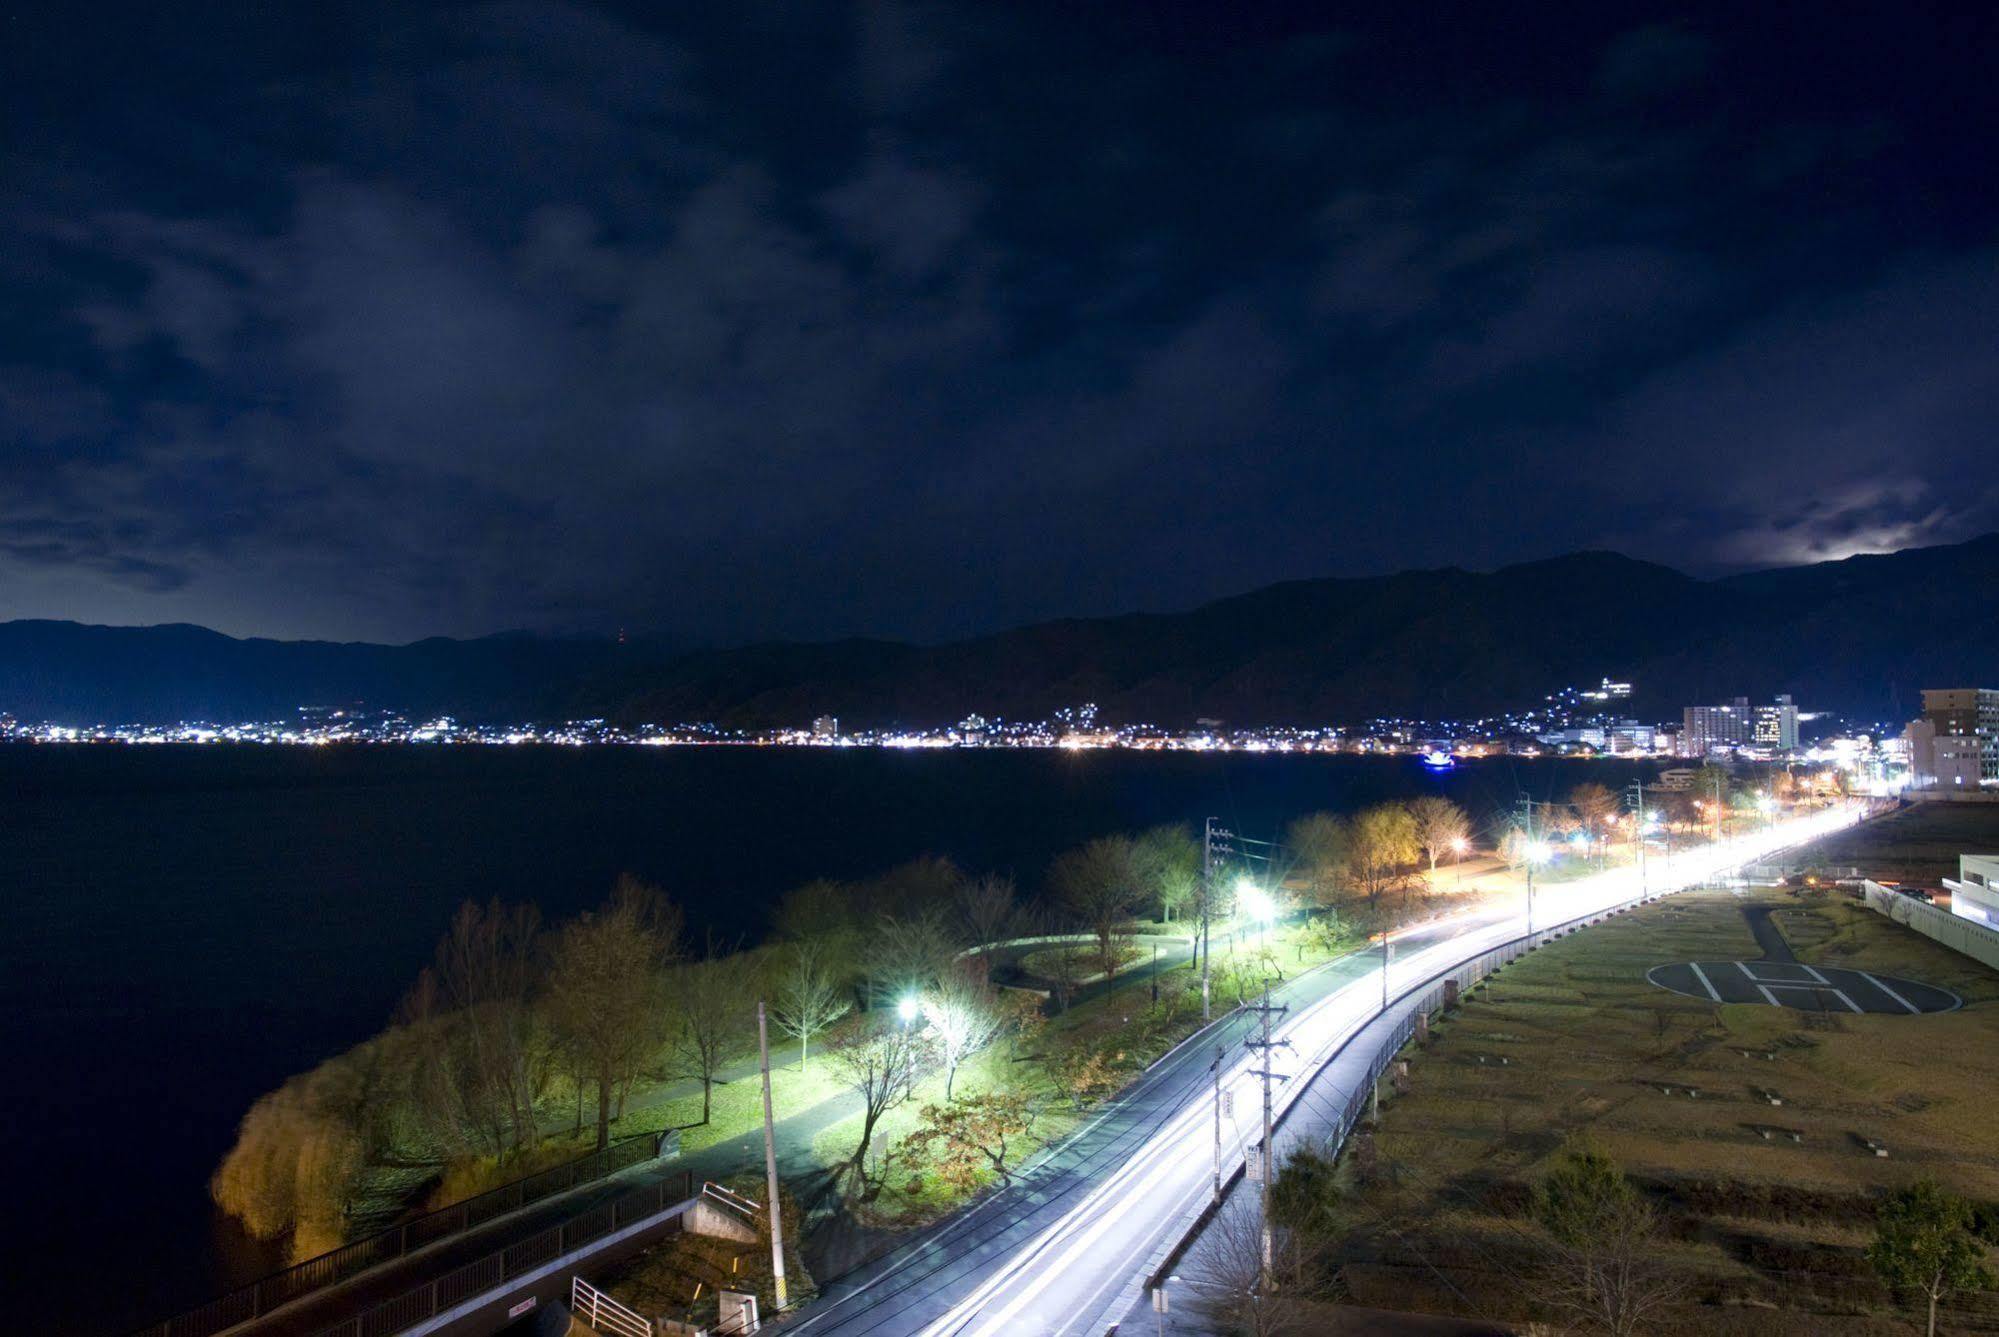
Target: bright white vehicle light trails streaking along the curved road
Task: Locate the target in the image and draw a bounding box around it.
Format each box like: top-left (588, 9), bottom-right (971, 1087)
top-left (922, 809), bottom-right (1857, 1337)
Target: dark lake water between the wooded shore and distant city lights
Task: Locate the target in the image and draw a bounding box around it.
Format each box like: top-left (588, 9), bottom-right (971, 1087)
top-left (0, 745), bottom-right (1637, 1333)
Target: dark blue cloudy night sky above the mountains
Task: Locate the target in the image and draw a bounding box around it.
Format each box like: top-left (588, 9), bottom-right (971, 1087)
top-left (0, 0), bottom-right (1999, 644)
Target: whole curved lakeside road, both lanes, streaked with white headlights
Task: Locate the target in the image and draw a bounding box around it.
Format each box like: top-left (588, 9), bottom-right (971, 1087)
top-left (788, 811), bottom-right (1855, 1337)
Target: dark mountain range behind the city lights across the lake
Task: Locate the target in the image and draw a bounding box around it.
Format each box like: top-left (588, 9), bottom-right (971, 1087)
top-left (0, 534), bottom-right (1999, 727)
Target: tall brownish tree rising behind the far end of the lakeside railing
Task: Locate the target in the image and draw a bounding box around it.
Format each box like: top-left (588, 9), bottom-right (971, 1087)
top-left (542, 877), bottom-right (682, 1149)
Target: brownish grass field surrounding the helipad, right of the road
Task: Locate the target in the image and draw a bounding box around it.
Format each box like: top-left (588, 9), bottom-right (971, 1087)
top-left (1341, 889), bottom-right (1999, 1337)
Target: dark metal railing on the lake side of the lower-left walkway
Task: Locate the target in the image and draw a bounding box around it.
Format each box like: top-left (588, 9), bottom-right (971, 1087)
top-left (132, 1133), bottom-right (662, 1337)
